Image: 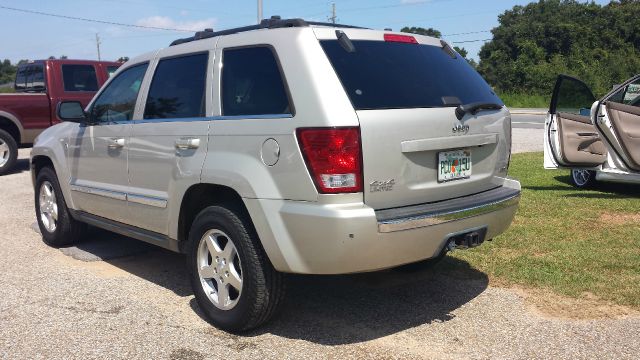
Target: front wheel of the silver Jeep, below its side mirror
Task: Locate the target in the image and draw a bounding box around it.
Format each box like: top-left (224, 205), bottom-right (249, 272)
top-left (35, 167), bottom-right (86, 247)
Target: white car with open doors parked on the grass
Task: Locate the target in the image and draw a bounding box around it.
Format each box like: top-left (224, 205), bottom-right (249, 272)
top-left (544, 75), bottom-right (640, 188)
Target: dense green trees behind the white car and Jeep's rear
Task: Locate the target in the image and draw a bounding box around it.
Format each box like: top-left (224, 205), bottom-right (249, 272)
top-left (401, 0), bottom-right (640, 96)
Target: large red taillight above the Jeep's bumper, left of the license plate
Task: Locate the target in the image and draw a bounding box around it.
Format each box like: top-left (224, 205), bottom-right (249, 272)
top-left (298, 127), bottom-right (362, 194)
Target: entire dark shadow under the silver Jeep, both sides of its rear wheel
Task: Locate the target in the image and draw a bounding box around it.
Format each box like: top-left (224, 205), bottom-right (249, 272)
top-left (61, 229), bottom-right (489, 345)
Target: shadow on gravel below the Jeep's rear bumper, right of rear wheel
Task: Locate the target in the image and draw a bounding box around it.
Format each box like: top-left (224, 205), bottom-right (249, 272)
top-left (249, 257), bottom-right (488, 345)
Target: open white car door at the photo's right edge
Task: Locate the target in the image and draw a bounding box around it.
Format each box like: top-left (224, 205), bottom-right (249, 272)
top-left (595, 75), bottom-right (640, 173)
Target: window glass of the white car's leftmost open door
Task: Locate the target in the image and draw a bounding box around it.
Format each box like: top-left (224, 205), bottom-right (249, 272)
top-left (552, 77), bottom-right (596, 116)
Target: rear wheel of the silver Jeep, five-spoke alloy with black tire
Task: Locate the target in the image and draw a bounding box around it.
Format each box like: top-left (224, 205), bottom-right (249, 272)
top-left (188, 206), bottom-right (284, 332)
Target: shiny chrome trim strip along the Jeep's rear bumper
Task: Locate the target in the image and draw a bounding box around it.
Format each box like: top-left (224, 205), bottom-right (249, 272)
top-left (378, 191), bottom-right (520, 233)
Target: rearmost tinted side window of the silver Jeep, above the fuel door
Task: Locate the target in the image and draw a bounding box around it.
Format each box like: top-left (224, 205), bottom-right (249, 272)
top-left (222, 47), bottom-right (291, 116)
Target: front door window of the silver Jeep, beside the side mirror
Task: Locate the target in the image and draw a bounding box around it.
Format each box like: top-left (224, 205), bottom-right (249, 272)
top-left (91, 64), bottom-right (148, 122)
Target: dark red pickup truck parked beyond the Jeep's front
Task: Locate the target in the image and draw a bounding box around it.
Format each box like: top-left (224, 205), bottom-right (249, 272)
top-left (0, 60), bottom-right (121, 175)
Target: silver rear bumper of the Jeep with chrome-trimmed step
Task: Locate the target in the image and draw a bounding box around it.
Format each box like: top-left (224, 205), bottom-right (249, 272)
top-left (245, 179), bottom-right (520, 274)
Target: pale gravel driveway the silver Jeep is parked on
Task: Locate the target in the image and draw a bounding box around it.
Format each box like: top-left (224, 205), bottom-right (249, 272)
top-left (0, 149), bottom-right (640, 359)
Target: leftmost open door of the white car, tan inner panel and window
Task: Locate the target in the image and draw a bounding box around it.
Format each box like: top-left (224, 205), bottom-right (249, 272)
top-left (544, 75), bottom-right (608, 169)
